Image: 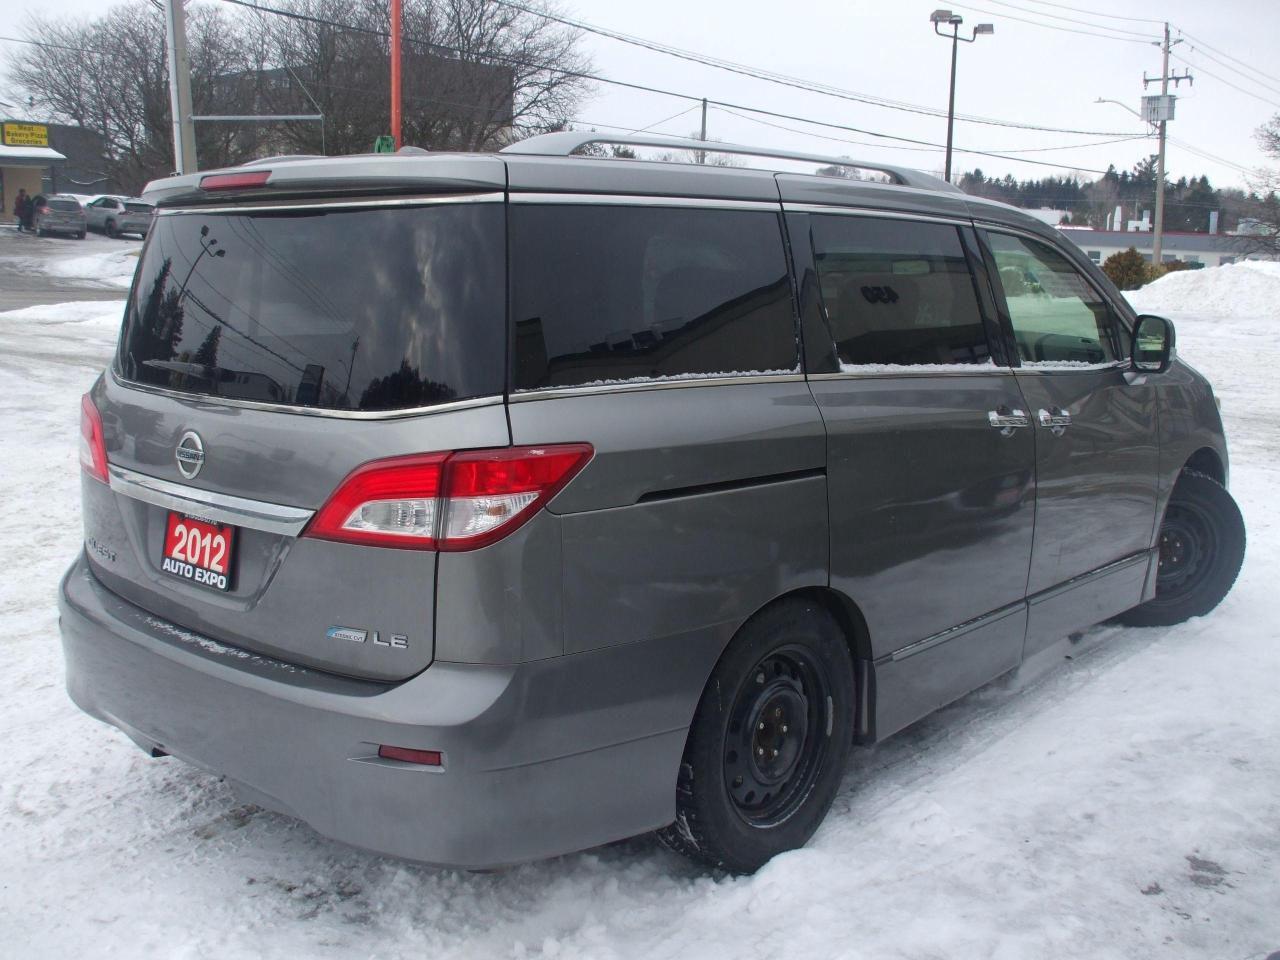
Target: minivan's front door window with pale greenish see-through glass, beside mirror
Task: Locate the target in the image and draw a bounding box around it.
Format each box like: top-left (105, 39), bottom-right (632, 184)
top-left (987, 233), bottom-right (1119, 366)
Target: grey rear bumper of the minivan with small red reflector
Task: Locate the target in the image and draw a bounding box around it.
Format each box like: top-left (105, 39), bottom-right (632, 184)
top-left (59, 557), bottom-right (692, 868)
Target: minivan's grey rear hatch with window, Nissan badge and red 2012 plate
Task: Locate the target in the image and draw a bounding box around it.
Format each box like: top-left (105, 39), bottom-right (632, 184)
top-left (84, 195), bottom-right (509, 681)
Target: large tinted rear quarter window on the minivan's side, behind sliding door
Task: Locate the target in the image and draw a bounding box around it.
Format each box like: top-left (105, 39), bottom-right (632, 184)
top-left (511, 205), bottom-right (796, 389)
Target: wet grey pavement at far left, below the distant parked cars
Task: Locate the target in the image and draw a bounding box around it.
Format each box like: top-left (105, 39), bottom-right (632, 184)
top-left (0, 224), bottom-right (138, 311)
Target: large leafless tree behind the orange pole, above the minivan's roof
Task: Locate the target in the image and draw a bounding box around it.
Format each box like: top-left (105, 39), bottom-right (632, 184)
top-left (239, 0), bottom-right (590, 154)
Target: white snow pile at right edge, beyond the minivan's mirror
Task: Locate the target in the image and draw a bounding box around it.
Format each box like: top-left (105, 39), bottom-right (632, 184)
top-left (1125, 260), bottom-right (1280, 317)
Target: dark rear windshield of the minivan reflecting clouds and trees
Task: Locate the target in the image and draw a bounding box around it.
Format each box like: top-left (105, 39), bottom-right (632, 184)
top-left (119, 204), bottom-right (506, 411)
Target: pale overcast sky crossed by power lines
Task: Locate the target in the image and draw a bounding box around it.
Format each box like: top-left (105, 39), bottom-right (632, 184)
top-left (0, 0), bottom-right (1280, 192)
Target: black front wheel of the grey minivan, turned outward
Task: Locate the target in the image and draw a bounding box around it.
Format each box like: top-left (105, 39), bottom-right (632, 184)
top-left (1119, 471), bottom-right (1245, 627)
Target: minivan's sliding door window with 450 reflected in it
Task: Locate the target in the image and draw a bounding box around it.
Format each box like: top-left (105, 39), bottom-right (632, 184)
top-left (810, 215), bottom-right (991, 371)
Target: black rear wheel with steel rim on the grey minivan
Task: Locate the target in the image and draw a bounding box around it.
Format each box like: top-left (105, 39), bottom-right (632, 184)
top-left (659, 599), bottom-right (855, 873)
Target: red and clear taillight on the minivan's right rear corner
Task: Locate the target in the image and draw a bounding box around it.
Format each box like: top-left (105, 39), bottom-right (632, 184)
top-left (305, 443), bottom-right (591, 550)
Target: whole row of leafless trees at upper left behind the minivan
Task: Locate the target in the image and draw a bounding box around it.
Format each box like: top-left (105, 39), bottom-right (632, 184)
top-left (5, 0), bottom-right (590, 191)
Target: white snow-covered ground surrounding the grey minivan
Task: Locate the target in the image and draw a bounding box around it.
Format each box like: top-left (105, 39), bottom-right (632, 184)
top-left (0, 264), bottom-right (1280, 960)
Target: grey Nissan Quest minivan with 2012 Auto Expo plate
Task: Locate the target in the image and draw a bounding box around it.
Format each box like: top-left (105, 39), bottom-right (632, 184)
top-left (60, 132), bottom-right (1244, 872)
